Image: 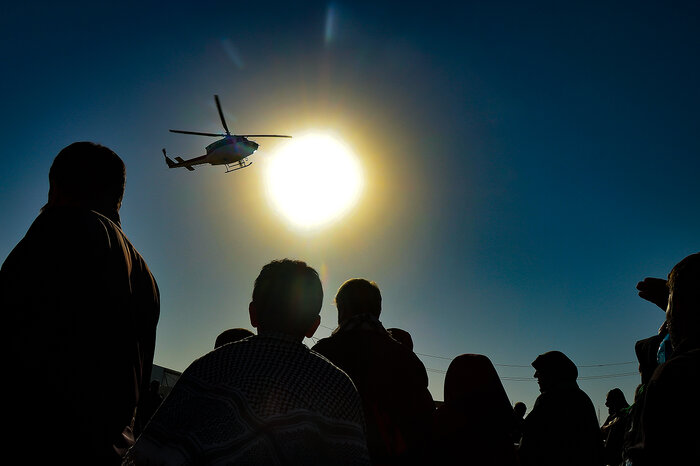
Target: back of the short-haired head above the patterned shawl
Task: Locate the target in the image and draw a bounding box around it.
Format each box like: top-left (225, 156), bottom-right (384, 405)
top-left (253, 259), bottom-right (323, 335)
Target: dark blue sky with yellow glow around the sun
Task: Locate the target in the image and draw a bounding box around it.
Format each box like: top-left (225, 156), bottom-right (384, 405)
top-left (0, 1), bottom-right (700, 418)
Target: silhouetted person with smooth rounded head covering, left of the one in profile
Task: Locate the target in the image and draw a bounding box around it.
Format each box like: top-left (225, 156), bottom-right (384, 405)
top-left (430, 354), bottom-right (518, 466)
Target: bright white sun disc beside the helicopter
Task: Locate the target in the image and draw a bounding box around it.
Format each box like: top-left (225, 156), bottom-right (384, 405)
top-left (265, 133), bottom-right (364, 230)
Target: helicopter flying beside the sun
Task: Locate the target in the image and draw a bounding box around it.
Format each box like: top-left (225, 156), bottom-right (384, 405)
top-left (163, 95), bottom-right (291, 173)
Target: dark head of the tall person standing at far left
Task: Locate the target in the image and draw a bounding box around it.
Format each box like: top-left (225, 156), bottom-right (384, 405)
top-left (49, 141), bottom-right (126, 211)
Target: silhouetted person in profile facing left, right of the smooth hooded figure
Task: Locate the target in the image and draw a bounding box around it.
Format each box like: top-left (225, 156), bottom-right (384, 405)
top-left (519, 351), bottom-right (603, 466)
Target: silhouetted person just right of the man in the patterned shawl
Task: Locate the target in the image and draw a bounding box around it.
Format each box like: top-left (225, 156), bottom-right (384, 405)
top-left (313, 278), bottom-right (435, 464)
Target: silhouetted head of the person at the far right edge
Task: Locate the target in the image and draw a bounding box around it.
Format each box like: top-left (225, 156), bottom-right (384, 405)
top-left (666, 253), bottom-right (700, 348)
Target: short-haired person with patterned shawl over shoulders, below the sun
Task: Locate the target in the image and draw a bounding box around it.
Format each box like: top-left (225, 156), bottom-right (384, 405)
top-left (125, 259), bottom-right (369, 465)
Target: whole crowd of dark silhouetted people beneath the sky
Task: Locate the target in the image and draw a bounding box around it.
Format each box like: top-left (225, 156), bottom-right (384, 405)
top-left (0, 142), bottom-right (700, 466)
